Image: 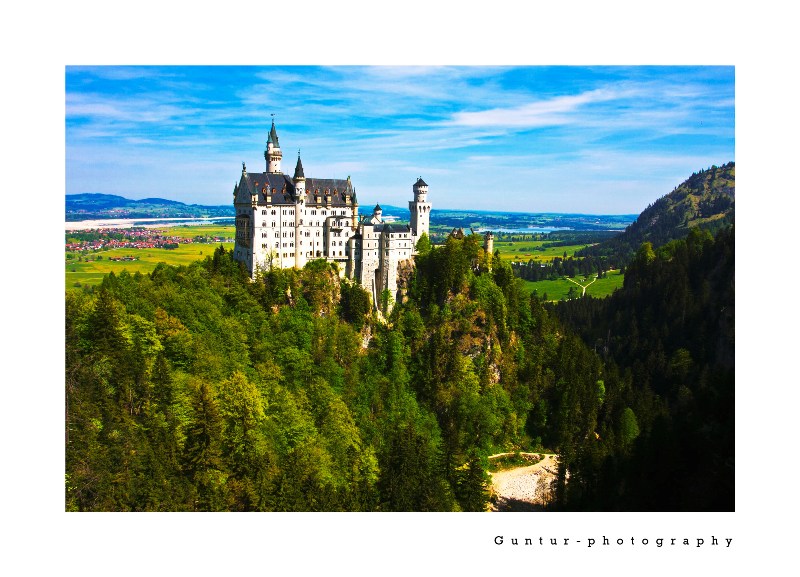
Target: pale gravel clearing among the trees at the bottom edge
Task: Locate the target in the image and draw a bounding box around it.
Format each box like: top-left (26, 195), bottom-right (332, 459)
top-left (490, 455), bottom-right (558, 511)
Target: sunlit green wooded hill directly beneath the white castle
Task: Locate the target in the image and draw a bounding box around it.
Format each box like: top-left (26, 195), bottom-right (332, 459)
top-left (65, 235), bottom-right (630, 511)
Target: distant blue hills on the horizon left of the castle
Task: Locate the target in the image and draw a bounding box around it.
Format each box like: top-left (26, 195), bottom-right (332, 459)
top-left (65, 193), bottom-right (234, 222)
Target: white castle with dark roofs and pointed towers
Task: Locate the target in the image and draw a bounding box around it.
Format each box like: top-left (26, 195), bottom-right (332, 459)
top-left (233, 121), bottom-right (431, 306)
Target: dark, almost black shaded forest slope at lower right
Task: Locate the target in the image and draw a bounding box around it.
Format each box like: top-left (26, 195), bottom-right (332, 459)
top-left (555, 226), bottom-right (735, 511)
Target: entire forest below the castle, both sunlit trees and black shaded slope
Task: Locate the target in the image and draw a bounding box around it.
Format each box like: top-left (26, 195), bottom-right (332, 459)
top-left (65, 228), bottom-right (734, 511)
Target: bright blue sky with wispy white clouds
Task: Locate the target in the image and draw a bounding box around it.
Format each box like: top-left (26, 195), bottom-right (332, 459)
top-left (66, 66), bottom-right (735, 214)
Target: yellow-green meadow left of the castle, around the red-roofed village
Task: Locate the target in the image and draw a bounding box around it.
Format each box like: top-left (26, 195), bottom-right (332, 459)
top-left (65, 225), bottom-right (234, 289)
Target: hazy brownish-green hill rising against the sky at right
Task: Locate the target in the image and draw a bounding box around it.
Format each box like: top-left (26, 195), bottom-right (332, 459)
top-left (576, 162), bottom-right (736, 267)
